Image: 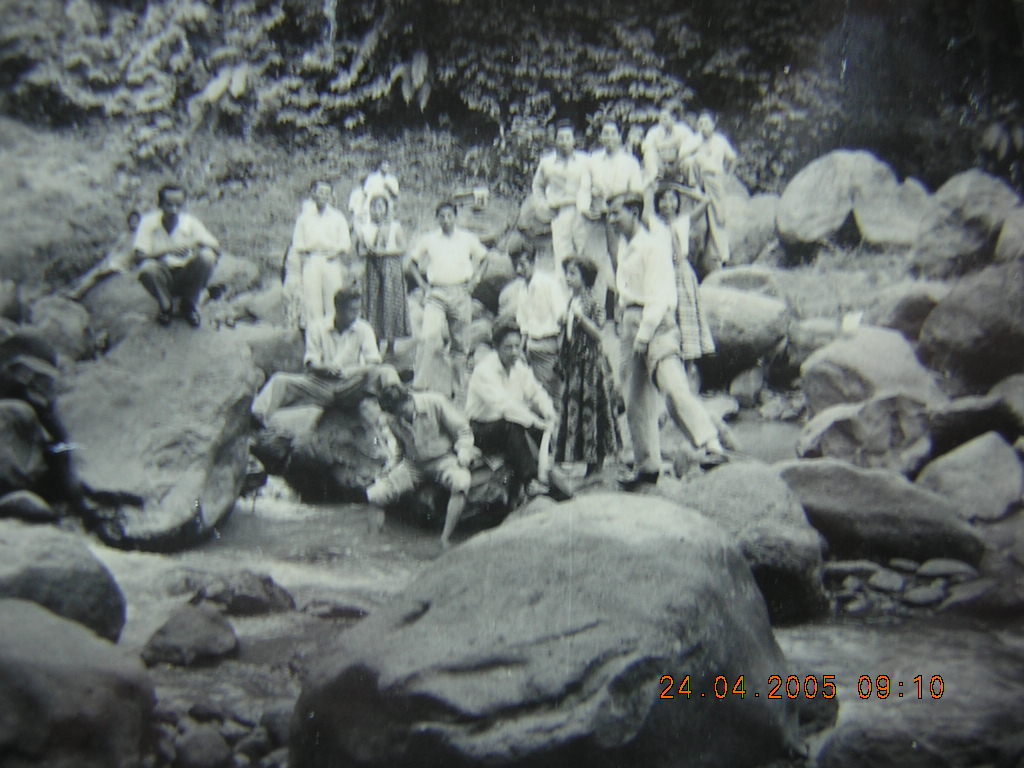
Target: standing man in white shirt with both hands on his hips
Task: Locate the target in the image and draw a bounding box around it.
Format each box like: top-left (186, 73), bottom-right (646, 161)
top-left (412, 201), bottom-right (487, 396)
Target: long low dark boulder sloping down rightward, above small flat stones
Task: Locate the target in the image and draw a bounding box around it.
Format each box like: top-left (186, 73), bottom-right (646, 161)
top-left (775, 459), bottom-right (984, 564)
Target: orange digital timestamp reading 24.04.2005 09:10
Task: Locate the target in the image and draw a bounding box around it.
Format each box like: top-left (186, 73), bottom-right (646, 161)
top-left (658, 675), bottom-right (945, 699)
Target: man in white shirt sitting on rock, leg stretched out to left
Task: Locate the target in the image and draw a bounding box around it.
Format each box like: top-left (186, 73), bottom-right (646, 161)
top-left (252, 289), bottom-right (387, 425)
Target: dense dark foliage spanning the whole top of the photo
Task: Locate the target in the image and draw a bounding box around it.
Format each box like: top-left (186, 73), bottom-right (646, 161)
top-left (0, 0), bottom-right (1024, 189)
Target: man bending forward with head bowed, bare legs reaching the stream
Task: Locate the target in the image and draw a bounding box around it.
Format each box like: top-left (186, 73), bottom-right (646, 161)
top-left (367, 385), bottom-right (479, 549)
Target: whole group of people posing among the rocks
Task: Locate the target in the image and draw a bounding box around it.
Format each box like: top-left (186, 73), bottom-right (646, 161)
top-left (72, 104), bottom-right (736, 545)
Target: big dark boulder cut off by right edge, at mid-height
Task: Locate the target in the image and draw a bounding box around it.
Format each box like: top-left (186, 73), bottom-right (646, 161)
top-left (919, 261), bottom-right (1024, 393)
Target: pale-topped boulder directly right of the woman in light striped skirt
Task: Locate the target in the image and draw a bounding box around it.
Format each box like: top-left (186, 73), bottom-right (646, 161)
top-left (699, 285), bottom-right (792, 387)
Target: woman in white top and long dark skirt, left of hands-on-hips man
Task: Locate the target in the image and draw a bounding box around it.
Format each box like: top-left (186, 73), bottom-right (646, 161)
top-left (358, 195), bottom-right (410, 353)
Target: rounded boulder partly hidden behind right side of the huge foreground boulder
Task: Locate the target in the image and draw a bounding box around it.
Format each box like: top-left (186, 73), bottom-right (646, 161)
top-left (678, 462), bottom-right (828, 623)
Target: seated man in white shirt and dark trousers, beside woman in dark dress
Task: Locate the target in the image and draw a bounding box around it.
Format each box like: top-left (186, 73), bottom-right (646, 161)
top-left (466, 321), bottom-right (556, 495)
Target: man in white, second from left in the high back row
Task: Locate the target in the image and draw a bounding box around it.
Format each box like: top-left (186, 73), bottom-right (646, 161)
top-left (580, 120), bottom-right (644, 315)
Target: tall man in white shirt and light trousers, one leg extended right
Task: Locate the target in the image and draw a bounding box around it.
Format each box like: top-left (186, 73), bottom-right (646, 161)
top-left (608, 194), bottom-right (725, 483)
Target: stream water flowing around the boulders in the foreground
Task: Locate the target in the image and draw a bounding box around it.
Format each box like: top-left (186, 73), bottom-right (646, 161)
top-left (94, 425), bottom-right (1024, 765)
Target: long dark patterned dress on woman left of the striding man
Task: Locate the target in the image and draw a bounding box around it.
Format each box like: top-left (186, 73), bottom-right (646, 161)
top-left (555, 293), bottom-right (620, 464)
